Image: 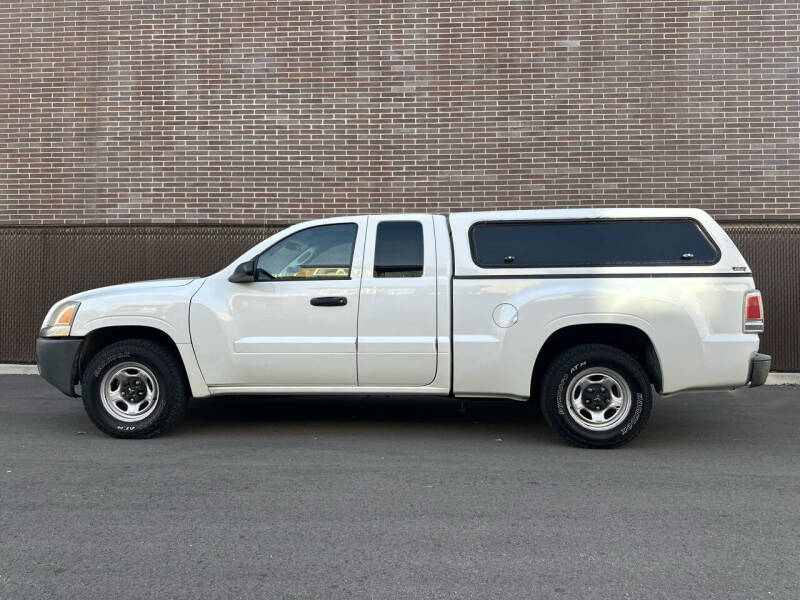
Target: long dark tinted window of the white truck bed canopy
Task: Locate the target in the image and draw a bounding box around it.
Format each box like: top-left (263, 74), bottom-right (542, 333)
top-left (470, 219), bottom-right (719, 268)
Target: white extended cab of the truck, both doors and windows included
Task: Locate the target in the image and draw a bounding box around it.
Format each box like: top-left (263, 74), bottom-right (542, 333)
top-left (189, 215), bottom-right (452, 394)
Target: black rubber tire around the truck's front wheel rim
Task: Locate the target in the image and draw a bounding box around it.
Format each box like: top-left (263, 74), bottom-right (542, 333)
top-left (81, 339), bottom-right (189, 438)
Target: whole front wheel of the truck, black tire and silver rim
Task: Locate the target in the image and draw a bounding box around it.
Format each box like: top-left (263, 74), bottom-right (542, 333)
top-left (81, 339), bottom-right (188, 438)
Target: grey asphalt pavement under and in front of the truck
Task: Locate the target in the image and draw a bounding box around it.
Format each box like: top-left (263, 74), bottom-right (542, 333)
top-left (0, 375), bottom-right (800, 600)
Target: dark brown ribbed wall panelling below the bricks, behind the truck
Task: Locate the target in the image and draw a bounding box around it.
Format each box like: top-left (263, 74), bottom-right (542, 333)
top-left (0, 222), bottom-right (800, 371)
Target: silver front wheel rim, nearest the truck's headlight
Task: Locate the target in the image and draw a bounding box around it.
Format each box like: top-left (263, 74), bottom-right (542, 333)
top-left (100, 362), bottom-right (158, 423)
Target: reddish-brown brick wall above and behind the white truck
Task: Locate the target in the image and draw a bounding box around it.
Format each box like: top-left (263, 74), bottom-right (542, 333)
top-left (0, 0), bottom-right (800, 224)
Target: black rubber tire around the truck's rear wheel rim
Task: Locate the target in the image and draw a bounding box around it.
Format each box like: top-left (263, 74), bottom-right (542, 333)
top-left (540, 344), bottom-right (653, 448)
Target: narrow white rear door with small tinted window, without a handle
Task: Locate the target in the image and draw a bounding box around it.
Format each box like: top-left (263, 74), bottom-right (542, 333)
top-left (358, 215), bottom-right (437, 386)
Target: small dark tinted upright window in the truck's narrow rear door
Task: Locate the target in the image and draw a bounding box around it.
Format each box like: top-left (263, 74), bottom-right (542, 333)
top-left (375, 221), bottom-right (424, 277)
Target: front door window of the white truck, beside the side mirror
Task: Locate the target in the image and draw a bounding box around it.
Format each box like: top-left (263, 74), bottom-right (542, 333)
top-left (256, 223), bottom-right (358, 281)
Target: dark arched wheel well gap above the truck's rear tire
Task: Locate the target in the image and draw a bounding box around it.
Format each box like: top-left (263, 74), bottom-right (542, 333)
top-left (531, 323), bottom-right (662, 398)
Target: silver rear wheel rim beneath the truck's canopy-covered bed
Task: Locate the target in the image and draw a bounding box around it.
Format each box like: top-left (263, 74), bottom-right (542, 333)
top-left (567, 367), bottom-right (631, 431)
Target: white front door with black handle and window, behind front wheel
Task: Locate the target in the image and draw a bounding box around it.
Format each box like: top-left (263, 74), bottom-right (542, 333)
top-left (190, 217), bottom-right (366, 387)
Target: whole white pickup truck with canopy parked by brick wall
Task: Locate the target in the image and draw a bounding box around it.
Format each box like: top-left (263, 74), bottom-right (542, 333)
top-left (37, 209), bottom-right (771, 447)
